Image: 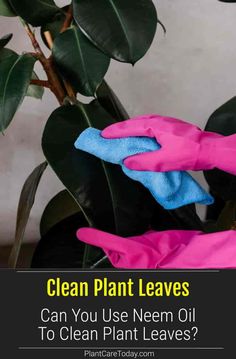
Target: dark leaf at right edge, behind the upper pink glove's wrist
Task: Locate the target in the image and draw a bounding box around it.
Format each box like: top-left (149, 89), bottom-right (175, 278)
top-left (204, 97), bottom-right (236, 201)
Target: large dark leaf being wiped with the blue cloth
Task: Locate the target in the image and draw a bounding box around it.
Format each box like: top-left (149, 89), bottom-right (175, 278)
top-left (42, 101), bottom-right (159, 235)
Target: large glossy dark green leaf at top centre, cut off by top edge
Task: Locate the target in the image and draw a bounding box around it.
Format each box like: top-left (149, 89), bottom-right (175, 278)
top-left (73, 0), bottom-right (157, 64)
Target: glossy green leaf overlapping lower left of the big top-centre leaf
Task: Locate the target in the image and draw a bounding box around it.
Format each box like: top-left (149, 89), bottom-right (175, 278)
top-left (52, 26), bottom-right (110, 96)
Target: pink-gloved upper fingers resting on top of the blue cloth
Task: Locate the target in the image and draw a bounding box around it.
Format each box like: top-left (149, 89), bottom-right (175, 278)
top-left (102, 115), bottom-right (165, 138)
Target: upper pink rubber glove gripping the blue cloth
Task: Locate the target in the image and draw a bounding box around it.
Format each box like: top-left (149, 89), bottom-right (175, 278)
top-left (102, 115), bottom-right (236, 175)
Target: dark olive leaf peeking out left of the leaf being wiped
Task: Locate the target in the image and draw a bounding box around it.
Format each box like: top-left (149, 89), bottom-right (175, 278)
top-left (40, 190), bottom-right (80, 236)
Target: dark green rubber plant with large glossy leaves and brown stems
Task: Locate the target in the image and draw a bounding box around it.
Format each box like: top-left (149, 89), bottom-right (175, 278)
top-left (0, 0), bottom-right (234, 267)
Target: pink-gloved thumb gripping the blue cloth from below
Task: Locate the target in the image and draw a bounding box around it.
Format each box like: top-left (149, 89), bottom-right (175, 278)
top-left (124, 148), bottom-right (173, 172)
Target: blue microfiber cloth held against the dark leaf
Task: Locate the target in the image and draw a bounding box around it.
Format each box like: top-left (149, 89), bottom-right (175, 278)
top-left (75, 128), bottom-right (214, 209)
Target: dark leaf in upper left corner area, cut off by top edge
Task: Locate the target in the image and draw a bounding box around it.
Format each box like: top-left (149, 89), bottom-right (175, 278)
top-left (9, 0), bottom-right (61, 26)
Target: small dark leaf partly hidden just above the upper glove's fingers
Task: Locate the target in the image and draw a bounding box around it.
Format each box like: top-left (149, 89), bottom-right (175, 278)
top-left (96, 80), bottom-right (129, 121)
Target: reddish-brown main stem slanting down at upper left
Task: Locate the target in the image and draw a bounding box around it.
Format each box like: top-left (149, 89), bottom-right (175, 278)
top-left (24, 22), bottom-right (66, 105)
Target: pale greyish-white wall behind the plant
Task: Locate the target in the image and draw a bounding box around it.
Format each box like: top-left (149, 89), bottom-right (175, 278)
top-left (0, 0), bottom-right (236, 243)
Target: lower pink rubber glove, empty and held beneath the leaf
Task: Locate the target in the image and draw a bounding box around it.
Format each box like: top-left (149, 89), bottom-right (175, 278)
top-left (77, 228), bottom-right (236, 269)
